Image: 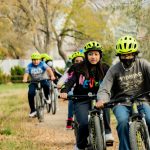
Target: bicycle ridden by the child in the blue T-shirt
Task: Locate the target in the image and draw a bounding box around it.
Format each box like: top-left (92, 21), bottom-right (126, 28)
top-left (27, 79), bottom-right (50, 122)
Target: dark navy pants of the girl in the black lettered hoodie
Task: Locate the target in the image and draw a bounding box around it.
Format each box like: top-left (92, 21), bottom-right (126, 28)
top-left (74, 101), bottom-right (111, 149)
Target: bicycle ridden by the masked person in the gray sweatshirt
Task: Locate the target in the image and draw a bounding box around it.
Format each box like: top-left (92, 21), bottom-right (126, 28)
top-left (104, 91), bottom-right (150, 150)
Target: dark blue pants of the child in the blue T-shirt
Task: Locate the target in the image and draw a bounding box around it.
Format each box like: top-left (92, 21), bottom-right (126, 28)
top-left (28, 80), bottom-right (50, 112)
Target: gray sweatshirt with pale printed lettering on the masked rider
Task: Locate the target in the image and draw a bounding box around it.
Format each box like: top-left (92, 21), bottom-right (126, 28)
top-left (97, 58), bottom-right (150, 102)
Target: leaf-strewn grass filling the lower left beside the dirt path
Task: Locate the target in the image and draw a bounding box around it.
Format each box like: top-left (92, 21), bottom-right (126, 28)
top-left (0, 84), bottom-right (118, 150)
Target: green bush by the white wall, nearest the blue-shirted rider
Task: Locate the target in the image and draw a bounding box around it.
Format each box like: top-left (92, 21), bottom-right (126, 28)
top-left (11, 66), bottom-right (25, 83)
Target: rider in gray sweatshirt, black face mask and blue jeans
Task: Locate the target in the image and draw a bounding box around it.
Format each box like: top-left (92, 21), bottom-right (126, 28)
top-left (96, 35), bottom-right (150, 150)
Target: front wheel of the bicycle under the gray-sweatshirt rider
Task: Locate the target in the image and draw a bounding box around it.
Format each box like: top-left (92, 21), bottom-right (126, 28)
top-left (129, 121), bottom-right (150, 150)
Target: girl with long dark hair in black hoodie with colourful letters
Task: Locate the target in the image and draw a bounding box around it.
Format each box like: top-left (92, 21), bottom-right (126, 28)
top-left (60, 41), bottom-right (113, 150)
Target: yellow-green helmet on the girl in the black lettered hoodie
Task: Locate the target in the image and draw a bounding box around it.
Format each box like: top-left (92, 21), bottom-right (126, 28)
top-left (84, 41), bottom-right (103, 53)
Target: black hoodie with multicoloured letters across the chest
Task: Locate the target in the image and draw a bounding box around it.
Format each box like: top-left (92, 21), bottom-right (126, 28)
top-left (61, 61), bottom-right (109, 95)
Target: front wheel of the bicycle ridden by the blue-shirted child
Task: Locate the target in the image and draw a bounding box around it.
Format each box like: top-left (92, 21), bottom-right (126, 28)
top-left (35, 91), bottom-right (44, 122)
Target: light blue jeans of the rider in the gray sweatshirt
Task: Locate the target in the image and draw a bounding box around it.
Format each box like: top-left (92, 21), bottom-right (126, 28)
top-left (113, 104), bottom-right (150, 150)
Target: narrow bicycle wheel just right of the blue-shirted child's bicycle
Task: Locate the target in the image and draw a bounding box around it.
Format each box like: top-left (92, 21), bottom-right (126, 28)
top-left (50, 83), bottom-right (58, 115)
